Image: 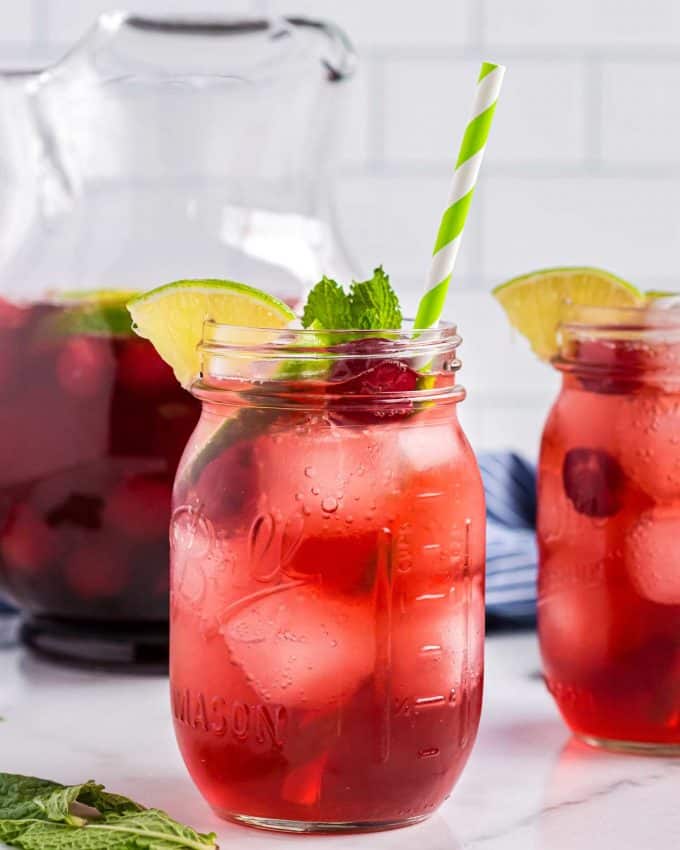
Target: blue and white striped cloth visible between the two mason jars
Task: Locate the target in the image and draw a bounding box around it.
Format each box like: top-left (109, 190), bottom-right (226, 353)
top-left (478, 452), bottom-right (538, 625)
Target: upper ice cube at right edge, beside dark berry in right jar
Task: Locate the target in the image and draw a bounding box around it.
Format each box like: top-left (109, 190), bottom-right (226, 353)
top-left (614, 395), bottom-right (680, 501)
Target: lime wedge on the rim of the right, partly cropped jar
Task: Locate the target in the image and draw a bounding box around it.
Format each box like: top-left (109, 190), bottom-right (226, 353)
top-left (493, 267), bottom-right (645, 360)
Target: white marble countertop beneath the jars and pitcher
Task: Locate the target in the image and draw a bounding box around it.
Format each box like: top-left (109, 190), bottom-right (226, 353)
top-left (0, 634), bottom-right (680, 850)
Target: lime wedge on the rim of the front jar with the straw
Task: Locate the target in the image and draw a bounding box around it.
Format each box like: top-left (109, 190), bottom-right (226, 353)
top-left (128, 280), bottom-right (295, 387)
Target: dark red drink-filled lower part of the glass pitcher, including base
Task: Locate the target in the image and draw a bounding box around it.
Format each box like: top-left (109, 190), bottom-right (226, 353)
top-left (0, 293), bottom-right (198, 664)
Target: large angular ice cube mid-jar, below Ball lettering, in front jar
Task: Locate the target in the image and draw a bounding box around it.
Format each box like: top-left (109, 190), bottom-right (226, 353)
top-left (220, 581), bottom-right (375, 710)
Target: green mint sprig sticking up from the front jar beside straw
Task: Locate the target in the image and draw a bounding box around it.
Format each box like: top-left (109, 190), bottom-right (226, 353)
top-left (302, 266), bottom-right (403, 330)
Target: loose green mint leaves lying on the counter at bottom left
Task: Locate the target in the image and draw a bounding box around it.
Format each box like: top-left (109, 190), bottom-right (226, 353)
top-left (0, 773), bottom-right (217, 850)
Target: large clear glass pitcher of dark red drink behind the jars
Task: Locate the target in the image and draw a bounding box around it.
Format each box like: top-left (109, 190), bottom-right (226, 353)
top-left (0, 12), bottom-right (355, 667)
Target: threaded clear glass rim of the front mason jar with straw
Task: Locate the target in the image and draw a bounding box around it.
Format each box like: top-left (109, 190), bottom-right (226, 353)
top-left (192, 319), bottom-right (464, 406)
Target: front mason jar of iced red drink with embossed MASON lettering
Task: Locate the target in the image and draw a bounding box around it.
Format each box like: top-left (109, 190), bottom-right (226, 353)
top-left (170, 323), bottom-right (485, 831)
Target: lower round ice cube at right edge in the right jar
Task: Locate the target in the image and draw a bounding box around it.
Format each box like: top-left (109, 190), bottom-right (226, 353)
top-left (625, 507), bottom-right (680, 605)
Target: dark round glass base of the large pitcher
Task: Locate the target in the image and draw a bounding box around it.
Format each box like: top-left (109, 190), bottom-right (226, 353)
top-left (19, 617), bottom-right (168, 673)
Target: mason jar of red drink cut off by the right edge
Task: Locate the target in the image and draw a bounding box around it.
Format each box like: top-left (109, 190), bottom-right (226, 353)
top-left (538, 308), bottom-right (680, 753)
